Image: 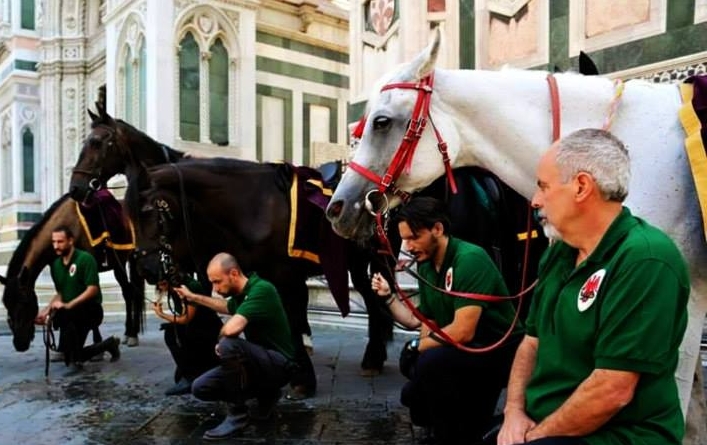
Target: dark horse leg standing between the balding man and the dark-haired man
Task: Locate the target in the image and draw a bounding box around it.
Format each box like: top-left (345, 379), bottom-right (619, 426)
top-left (348, 244), bottom-right (393, 377)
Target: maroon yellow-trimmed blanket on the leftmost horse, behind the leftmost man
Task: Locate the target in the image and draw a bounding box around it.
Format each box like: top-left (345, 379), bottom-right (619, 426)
top-left (76, 190), bottom-right (135, 250)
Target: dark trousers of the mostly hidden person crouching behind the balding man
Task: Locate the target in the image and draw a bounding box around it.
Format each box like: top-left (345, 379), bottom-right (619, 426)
top-left (162, 323), bottom-right (221, 382)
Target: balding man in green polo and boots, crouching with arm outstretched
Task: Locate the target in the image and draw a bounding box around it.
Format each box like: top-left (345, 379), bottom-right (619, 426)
top-left (180, 253), bottom-right (295, 440)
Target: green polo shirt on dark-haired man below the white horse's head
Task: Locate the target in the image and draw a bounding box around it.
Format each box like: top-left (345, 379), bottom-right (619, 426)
top-left (418, 237), bottom-right (522, 347)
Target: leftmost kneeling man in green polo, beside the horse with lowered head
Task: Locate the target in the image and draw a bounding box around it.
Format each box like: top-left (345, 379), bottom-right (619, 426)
top-left (36, 226), bottom-right (120, 366)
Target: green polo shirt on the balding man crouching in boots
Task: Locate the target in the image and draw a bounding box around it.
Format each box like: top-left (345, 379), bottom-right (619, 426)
top-left (227, 273), bottom-right (295, 359)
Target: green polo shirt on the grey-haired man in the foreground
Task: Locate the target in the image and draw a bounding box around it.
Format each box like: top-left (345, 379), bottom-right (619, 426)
top-left (526, 207), bottom-right (690, 445)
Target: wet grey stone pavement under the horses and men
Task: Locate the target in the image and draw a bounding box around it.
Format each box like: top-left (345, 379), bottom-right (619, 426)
top-left (0, 320), bottom-right (419, 445)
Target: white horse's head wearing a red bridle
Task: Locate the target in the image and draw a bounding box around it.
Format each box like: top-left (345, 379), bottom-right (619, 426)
top-left (326, 29), bottom-right (459, 242)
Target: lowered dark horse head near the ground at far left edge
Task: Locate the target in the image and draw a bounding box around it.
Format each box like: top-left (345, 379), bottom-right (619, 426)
top-left (0, 268), bottom-right (39, 352)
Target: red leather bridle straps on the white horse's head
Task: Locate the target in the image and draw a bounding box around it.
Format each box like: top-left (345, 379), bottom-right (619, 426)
top-left (348, 72), bottom-right (457, 201)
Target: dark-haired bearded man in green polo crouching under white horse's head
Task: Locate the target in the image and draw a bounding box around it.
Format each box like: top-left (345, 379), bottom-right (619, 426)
top-left (371, 197), bottom-right (522, 444)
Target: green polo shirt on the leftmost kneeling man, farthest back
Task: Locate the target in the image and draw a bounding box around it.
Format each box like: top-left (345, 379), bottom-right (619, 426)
top-left (49, 248), bottom-right (103, 304)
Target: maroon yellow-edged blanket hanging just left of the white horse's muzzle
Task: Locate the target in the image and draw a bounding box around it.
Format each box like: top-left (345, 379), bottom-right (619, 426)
top-left (287, 167), bottom-right (351, 317)
